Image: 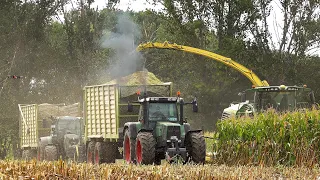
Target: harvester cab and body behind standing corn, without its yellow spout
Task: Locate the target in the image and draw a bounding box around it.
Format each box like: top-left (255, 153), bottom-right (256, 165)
top-left (221, 85), bottom-right (317, 120)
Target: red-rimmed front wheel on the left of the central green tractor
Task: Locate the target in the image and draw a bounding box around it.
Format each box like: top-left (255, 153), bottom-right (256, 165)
top-left (136, 132), bottom-right (156, 165)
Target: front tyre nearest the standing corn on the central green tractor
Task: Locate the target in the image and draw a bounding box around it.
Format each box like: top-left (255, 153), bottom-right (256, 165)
top-left (186, 132), bottom-right (206, 164)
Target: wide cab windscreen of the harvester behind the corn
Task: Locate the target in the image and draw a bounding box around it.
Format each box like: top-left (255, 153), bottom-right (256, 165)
top-left (254, 90), bottom-right (312, 111)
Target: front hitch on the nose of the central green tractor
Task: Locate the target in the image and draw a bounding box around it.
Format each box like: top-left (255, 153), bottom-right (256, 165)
top-left (166, 136), bottom-right (187, 161)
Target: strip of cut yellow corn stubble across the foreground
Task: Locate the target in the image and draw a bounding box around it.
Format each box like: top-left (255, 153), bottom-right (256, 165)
top-left (0, 160), bottom-right (320, 180)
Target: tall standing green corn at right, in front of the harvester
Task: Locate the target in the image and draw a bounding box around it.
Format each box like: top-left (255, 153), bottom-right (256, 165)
top-left (212, 107), bottom-right (320, 167)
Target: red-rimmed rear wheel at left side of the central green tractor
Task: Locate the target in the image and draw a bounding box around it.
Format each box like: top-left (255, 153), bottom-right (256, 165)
top-left (123, 129), bottom-right (136, 163)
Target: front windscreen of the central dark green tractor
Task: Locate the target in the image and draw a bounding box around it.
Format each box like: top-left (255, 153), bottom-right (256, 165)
top-left (149, 103), bottom-right (178, 121)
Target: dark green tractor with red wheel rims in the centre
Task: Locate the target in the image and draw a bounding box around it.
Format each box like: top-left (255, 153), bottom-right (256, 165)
top-left (123, 93), bottom-right (206, 164)
